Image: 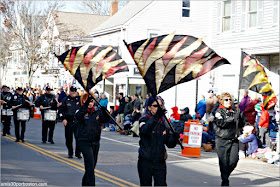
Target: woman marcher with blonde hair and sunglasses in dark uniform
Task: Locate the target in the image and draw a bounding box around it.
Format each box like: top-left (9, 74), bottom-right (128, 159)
top-left (214, 92), bottom-right (244, 186)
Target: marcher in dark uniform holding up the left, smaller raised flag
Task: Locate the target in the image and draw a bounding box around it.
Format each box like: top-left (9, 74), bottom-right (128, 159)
top-left (76, 94), bottom-right (110, 186)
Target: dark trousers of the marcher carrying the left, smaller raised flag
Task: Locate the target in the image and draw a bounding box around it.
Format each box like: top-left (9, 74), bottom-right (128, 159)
top-left (78, 141), bottom-right (100, 186)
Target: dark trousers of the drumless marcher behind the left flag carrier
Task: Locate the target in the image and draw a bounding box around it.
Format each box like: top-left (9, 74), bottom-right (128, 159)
top-left (65, 123), bottom-right (81, 155)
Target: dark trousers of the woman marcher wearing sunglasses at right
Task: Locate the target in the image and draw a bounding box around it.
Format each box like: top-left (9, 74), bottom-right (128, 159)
top-left (215, 138), bottom-right (239, 183)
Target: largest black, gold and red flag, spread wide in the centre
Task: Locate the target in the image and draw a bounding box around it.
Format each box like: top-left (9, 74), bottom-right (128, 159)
top-left (126, 33), bottom-right (230, 96)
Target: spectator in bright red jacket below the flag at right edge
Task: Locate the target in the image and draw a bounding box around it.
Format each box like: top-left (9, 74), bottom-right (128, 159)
top-left (259, 103), bottom-right (270, 147)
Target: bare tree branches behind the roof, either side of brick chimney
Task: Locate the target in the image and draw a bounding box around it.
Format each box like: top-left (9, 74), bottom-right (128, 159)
top-left (81, 0), bottom-right (130, 15)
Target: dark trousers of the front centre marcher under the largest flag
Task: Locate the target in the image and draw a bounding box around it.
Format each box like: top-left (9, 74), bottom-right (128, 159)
top-left (137, 157), bottom-right (167, 186)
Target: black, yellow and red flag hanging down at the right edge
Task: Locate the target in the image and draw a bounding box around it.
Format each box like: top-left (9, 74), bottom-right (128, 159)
top-left (240, 52), bottom-right (277, 109)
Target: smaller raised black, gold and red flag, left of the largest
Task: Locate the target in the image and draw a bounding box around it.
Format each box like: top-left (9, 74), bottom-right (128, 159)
top-left (57, 45), bottom-right (128, 91)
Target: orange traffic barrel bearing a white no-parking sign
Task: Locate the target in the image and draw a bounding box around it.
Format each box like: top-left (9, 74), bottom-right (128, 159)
top-left (181, 119), bottom-right (202, 157)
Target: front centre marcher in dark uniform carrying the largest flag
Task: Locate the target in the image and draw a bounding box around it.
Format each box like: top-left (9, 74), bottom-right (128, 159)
top-left (138, 97), bottom-right (179, 186)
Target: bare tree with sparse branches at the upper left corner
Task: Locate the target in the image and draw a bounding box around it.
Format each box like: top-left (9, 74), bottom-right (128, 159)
top-left (0, 0), bottom-right (63, 87)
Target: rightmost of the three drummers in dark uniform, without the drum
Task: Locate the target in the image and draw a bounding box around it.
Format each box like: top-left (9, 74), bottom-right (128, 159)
top-left (35, 86), bottom-right (59, 144)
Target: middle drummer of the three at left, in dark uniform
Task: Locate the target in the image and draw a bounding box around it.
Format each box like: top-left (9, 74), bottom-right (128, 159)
top-left (11, 87), bottom-right (32, 142)
